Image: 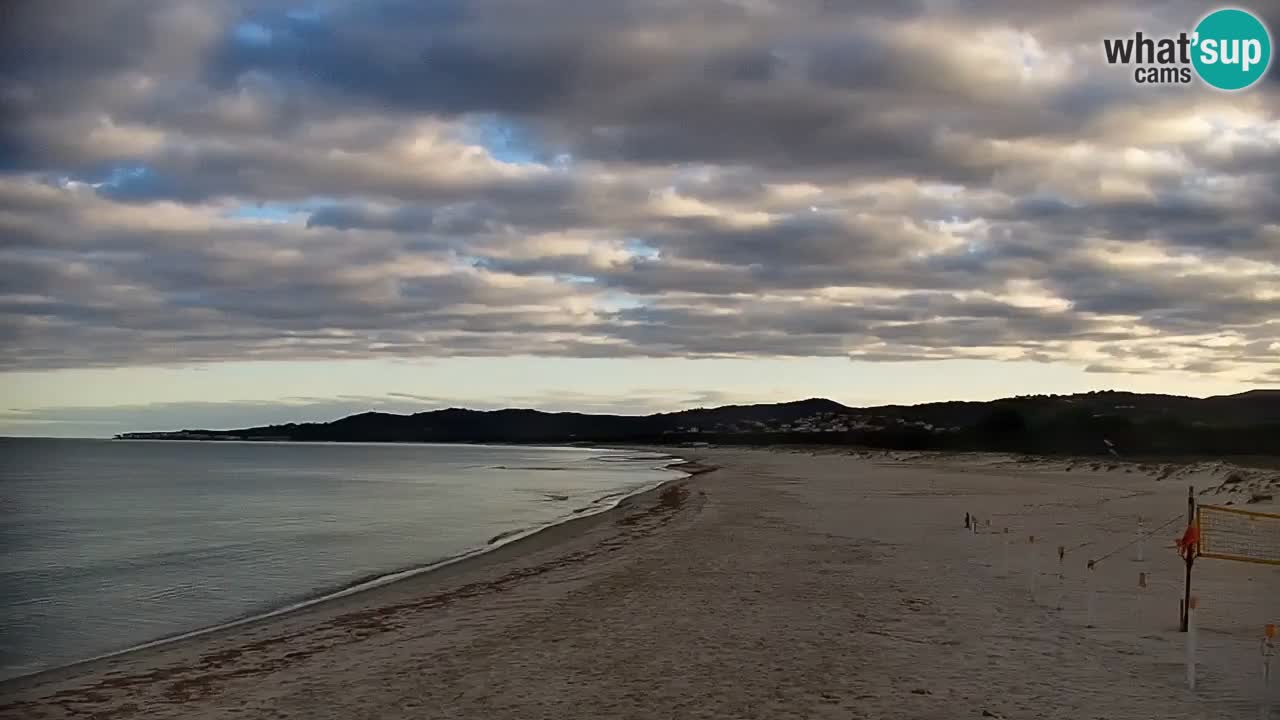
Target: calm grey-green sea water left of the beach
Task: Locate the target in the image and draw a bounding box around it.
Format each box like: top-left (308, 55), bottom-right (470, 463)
top-left (0, 438), bottom-right (669, 678)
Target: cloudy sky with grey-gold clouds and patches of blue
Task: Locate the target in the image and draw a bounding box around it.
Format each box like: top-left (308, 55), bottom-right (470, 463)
top-left (0, 0), bottom-right (1280, 437)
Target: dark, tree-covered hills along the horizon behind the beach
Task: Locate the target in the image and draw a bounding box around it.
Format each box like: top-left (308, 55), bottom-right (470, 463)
top-left (119, 389), bottom-right (1280, 455)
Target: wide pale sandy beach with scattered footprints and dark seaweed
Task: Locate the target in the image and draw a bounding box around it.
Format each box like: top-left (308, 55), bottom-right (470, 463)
top-left (0, 448), bottom-right (1280, 720)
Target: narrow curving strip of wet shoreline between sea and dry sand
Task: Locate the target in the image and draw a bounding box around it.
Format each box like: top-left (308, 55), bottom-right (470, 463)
top-left (0, 447), bottom-right (714, 700)
